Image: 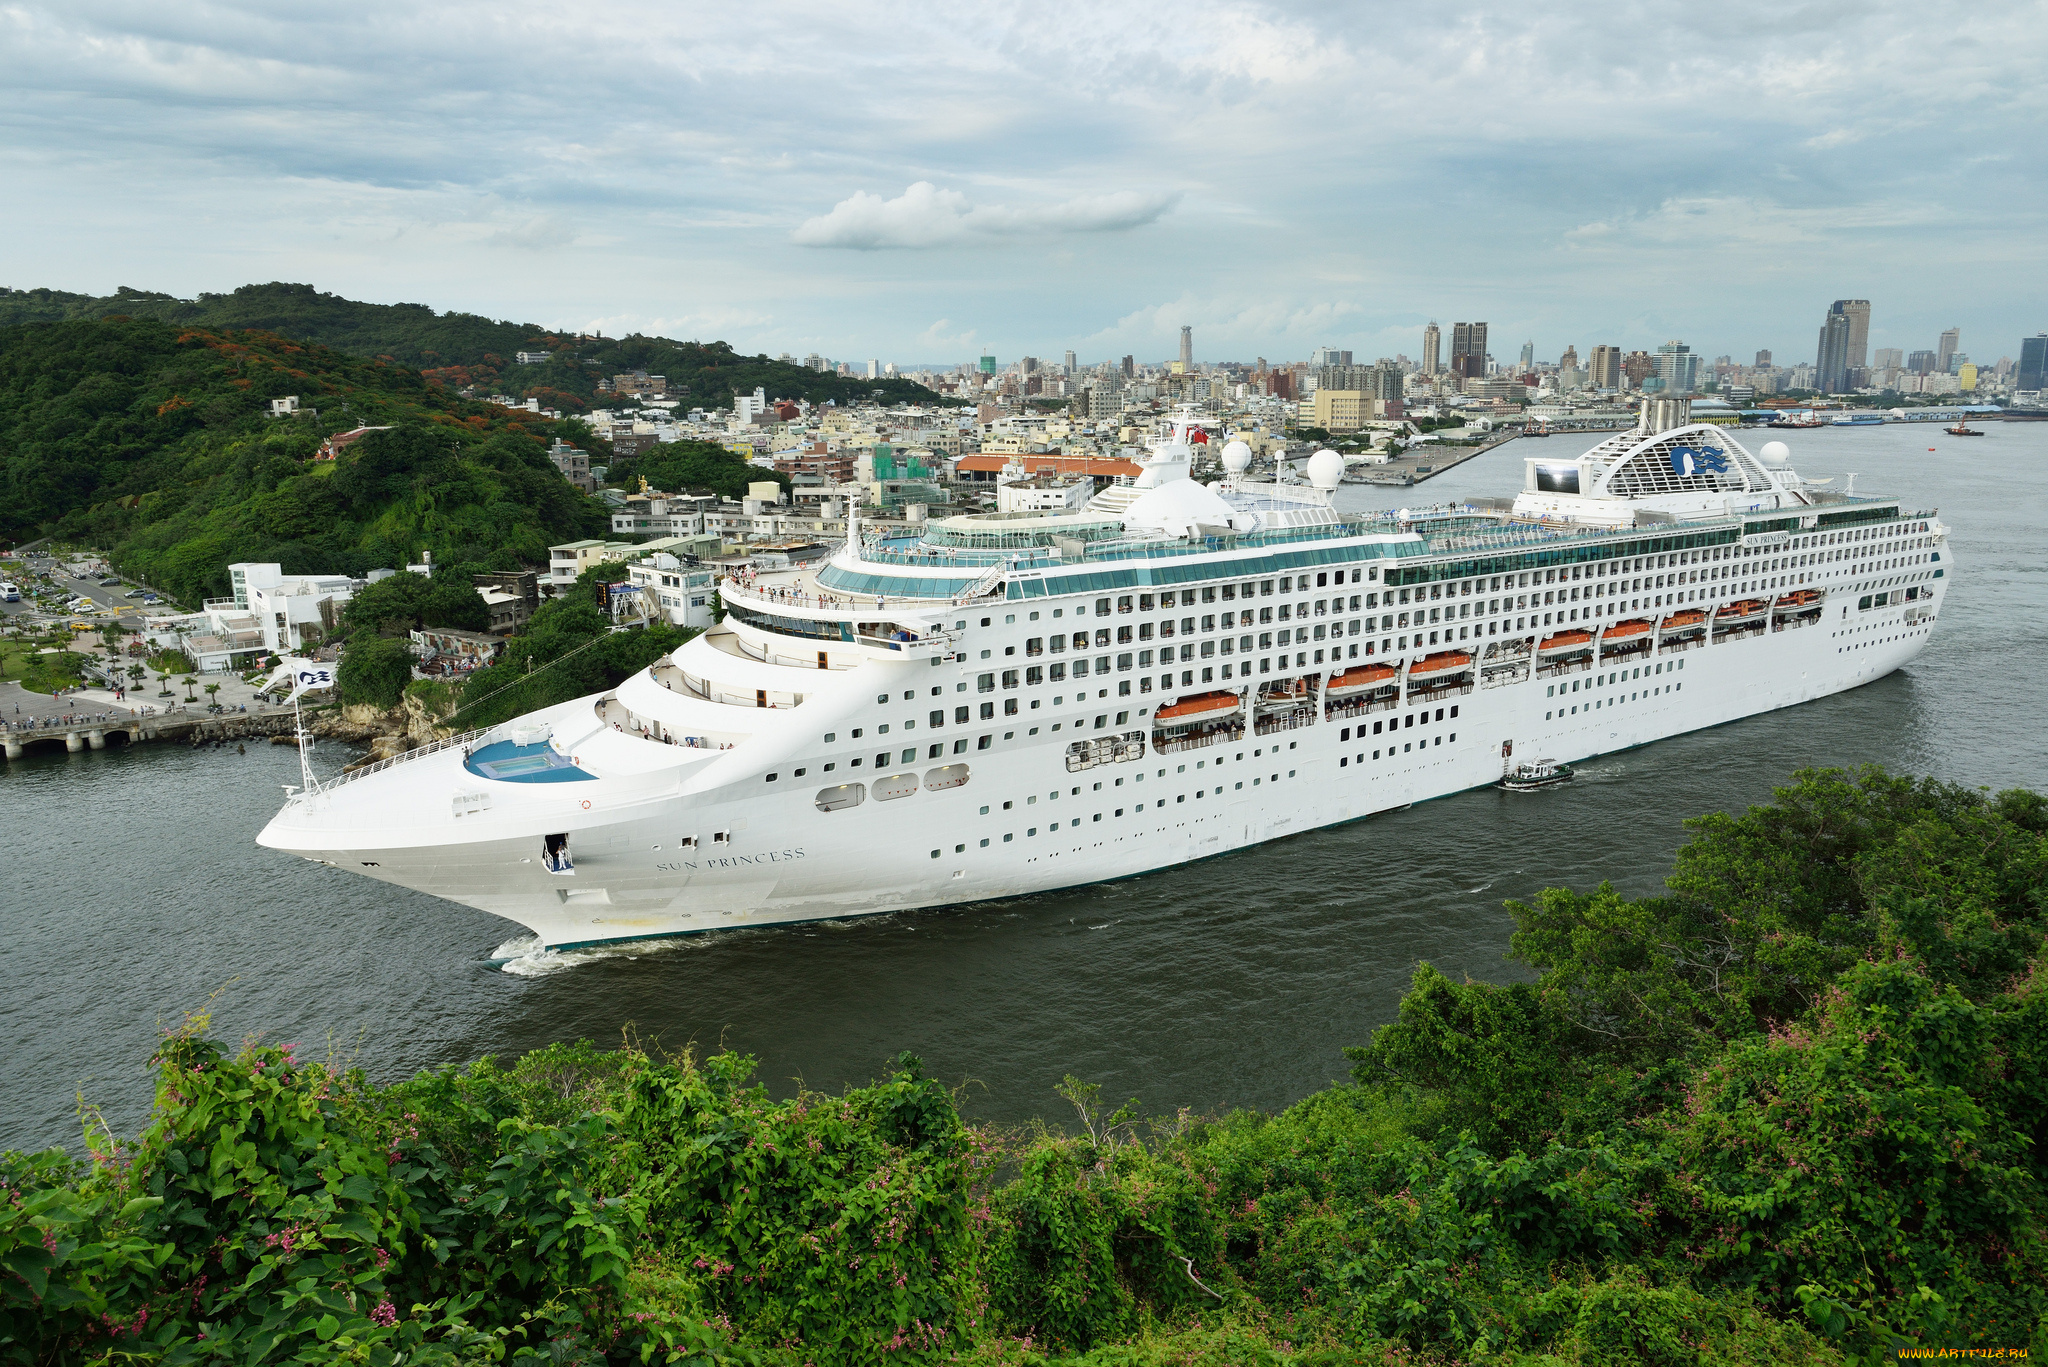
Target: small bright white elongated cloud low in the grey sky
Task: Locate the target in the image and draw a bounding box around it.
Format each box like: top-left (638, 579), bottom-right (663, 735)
top-left (791, 180), bottom-right (1176, 252)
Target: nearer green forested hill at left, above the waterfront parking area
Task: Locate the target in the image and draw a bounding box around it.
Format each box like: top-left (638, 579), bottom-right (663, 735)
top-left (0, 318), bottom-right (608, 603)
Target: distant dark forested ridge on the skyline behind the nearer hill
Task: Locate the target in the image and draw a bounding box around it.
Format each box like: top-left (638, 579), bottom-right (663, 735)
top-left (0, 281), bottom-right (954, 410)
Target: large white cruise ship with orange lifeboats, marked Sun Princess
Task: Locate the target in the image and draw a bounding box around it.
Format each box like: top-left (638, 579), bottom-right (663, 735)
top-left (260, 400), bottom-right (1954, 949)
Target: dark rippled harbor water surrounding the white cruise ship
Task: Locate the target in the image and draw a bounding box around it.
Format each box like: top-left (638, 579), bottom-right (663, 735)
top-left (0, 422), bottom-right (2048, 1150)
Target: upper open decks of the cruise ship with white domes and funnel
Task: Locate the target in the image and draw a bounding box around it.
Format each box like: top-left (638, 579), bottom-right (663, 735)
top-left (749, 409), bottom-right (1896, 615)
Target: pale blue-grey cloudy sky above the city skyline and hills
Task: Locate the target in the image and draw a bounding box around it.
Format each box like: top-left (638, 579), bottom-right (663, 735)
top-left (0, 0), bottom-right (2048, 363)
